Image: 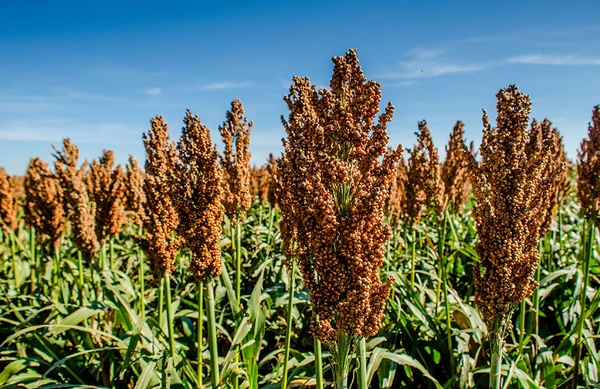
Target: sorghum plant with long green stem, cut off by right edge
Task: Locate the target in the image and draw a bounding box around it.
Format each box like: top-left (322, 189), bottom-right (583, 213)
top-left (573, 105), bottom-right (600, 389)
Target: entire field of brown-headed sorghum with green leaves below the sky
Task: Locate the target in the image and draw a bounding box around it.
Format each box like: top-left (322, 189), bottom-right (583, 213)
top-left (0, 50), bottom-right (600, 389)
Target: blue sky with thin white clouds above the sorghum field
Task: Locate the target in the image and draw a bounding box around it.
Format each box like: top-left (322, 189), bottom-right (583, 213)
top-left (0, 0), bottom-right (600, 174)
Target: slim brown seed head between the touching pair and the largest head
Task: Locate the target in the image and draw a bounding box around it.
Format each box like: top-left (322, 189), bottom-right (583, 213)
top-left (219, 99), bottom-right (253, 220)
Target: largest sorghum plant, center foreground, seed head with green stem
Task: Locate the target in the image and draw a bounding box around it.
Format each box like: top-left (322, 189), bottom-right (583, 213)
top-left (277, 50), bottom-right (401, 388)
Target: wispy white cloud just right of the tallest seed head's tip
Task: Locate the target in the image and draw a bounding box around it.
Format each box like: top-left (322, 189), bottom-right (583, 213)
top-left (383, 49), bottom-right (485, 79)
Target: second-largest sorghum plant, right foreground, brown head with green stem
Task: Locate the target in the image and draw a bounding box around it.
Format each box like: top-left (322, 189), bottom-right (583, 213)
top-left (463, 85), bottom-right (558, 389)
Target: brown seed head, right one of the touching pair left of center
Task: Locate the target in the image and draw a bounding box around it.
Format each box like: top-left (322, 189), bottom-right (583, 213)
top-left (174, 110), bottom-right (224, 280)
